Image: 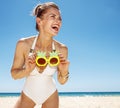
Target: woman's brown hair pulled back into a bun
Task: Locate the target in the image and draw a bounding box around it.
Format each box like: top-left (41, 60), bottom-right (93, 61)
top-left (33, 2), bottom-right (60, 31)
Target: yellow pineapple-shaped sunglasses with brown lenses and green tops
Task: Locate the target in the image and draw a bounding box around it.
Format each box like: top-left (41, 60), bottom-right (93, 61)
top-left (35, 51), bottom-right (60, 66)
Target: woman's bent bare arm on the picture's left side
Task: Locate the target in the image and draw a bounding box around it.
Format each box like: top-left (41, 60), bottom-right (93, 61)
top-left (11, 40), bottom-right (34, 79)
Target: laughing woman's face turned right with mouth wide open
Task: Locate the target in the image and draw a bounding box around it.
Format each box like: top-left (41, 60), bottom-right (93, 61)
top-left (39, 8), bottom-right (62, 36)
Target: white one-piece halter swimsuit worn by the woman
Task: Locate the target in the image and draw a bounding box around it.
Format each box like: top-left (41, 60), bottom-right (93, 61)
top-left (23, 37), bottom-right (57, 105)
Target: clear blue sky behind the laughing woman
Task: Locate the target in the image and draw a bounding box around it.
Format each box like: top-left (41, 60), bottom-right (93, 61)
top-left (0, 0), bottom-right (120, 92)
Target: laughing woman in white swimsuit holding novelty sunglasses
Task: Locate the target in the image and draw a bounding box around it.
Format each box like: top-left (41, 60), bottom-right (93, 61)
top-left (11, 2), bottom-right (69, 108)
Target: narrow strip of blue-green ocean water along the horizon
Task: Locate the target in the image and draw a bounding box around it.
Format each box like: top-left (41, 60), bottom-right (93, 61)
top-left (0, 92), bottom-right (120, 97)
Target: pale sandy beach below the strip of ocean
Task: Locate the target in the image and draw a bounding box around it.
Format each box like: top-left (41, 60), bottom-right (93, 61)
top-left (0, 96), bottom-right (120, 108)
